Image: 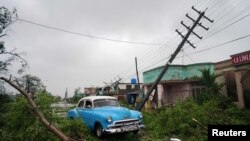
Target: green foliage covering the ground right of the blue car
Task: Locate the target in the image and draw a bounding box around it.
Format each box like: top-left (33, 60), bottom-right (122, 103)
top-left (141, 96), bottom-right (250, 141)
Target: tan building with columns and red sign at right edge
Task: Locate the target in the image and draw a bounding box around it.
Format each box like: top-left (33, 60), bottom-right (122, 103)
top-left (214, 51), bottom-right (250, 107)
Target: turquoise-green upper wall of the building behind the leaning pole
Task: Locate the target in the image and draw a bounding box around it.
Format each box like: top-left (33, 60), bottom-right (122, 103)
top-left (143, 63), bottom-right (214, 84)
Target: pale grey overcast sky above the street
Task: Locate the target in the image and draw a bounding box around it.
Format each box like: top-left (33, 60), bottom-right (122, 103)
top-left (0, 0), bottom-right (250, 96)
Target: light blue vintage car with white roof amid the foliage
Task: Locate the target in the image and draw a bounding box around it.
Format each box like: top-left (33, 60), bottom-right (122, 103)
top-left (67, 96), bottom-right (144, 137)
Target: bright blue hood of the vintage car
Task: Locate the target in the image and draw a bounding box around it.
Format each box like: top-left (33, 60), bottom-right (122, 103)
top-left (94, 106), bottom-right (131, 120)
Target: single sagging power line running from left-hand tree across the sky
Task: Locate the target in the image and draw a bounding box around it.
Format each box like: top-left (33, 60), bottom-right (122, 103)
top-left (16, 18), bottom-right (160, 46)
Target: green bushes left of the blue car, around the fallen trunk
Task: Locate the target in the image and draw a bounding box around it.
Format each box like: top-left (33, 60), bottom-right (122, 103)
top-left (0, 93), bottom-right (93, 141)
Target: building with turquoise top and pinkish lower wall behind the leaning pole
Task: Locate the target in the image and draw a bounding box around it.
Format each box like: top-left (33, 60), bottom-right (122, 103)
top-left (143, 63), bottom-right (214, 107)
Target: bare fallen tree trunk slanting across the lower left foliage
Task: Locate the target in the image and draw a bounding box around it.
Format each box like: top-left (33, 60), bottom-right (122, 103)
top-left (0, 77), bottom-right (73, 141)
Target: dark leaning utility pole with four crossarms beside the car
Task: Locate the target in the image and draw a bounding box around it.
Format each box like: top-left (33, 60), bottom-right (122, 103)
top-left (137, 6), bottom-right (213, 111)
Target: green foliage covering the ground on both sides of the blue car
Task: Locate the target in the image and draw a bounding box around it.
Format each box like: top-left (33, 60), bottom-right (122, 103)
top-left (0, 88), bottom-right (250, 141)
